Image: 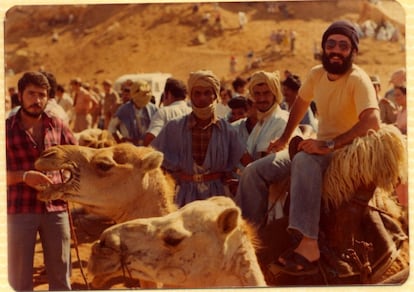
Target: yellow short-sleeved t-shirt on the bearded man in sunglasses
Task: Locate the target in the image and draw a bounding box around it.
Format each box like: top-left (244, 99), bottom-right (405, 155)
top-left (299, 65), bottom-right (378, 140)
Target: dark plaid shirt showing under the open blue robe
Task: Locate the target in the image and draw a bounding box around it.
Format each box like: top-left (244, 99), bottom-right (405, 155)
top-left (188, 113), bottom-right (220, 165)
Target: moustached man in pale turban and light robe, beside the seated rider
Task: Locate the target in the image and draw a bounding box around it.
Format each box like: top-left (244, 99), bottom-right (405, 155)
top-left (247, 71), bottom-right (300, 159)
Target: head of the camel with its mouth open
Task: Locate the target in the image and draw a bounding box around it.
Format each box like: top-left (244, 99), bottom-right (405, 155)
top-left (35, 143), bottom-right (174, 222)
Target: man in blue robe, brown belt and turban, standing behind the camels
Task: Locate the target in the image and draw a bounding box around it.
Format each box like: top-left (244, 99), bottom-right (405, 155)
top-left (151, 70), bottom-right (250, 207)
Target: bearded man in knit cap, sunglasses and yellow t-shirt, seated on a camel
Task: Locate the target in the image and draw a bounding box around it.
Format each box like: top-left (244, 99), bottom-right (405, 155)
top-left (236, 21), bottom-right (380, 275)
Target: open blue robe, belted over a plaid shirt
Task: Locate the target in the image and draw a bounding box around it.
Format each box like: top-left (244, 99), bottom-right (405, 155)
top-left (151, 115), bottom-right (245, 207)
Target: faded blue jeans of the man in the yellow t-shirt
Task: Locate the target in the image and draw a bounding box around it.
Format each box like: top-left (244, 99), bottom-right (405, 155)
top-left (235, 150), bottom-right (332, 239)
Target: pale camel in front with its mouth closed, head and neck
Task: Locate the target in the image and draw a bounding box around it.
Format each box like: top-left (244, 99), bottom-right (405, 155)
top-left (88, 196), bottom-right (266, 288)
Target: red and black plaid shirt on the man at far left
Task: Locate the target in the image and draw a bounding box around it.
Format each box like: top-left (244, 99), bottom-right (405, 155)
top-left (6, 110), bottom-right (77, 214)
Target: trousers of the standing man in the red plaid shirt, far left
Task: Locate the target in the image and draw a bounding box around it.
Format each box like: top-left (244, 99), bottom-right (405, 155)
top-left (7, 212), bottom-right (71, 291)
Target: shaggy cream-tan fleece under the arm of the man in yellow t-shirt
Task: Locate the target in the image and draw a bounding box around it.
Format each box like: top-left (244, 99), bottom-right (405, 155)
top-left (323, 125), bottom-right (408, 208)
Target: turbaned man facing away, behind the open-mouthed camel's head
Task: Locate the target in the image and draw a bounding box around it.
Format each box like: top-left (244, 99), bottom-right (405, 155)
top-left (108, 80), bottom-right (157, 146)
